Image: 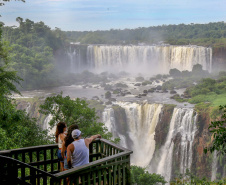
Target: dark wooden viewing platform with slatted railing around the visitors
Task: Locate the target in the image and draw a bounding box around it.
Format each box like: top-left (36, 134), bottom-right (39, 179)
top-left (0, 139), bottom-right (132, 185)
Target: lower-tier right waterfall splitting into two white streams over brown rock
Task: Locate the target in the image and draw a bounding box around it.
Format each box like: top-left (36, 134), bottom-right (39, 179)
top-left (157, 108), bottom-right (197, 181)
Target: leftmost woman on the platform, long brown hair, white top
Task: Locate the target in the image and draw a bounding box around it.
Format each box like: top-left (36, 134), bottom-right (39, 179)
top-left (55, 122), bottom-right (67, 171)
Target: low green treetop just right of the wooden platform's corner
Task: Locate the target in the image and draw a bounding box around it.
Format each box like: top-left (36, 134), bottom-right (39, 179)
top-left (131, 166), bottom-right (166, 185)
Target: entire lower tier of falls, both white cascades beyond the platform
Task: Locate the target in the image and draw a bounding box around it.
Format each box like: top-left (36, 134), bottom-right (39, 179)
top-left (103, 102), bottom-right (197, 181)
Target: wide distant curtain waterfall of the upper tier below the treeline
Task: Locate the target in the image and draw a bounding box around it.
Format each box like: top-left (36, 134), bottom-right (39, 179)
top-left (69, 45), bottom-right (212, 73)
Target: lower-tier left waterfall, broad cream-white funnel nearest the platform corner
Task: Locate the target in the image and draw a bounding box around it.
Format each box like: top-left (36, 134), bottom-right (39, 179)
top-left (103, 102), bottom-right (162, 167)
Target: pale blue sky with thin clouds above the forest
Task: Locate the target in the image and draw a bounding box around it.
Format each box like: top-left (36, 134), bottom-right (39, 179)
top-left (0, 0), bottom-right (226, 31)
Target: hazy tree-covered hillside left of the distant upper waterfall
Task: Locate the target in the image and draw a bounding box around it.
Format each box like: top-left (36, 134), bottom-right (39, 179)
top-left (2, 17), bottom-right (66, 89)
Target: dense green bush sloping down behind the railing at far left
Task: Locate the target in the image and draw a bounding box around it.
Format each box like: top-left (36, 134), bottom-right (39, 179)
top-left (0, 97), bottom-right (50, 150)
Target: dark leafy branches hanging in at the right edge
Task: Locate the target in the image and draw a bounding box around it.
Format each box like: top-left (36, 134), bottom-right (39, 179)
top-left (204, 105), bottom-right (226, 155)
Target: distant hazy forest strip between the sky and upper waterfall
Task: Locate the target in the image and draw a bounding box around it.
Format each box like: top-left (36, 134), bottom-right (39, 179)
top-left (66, 22), bottom-right (226, 47)
